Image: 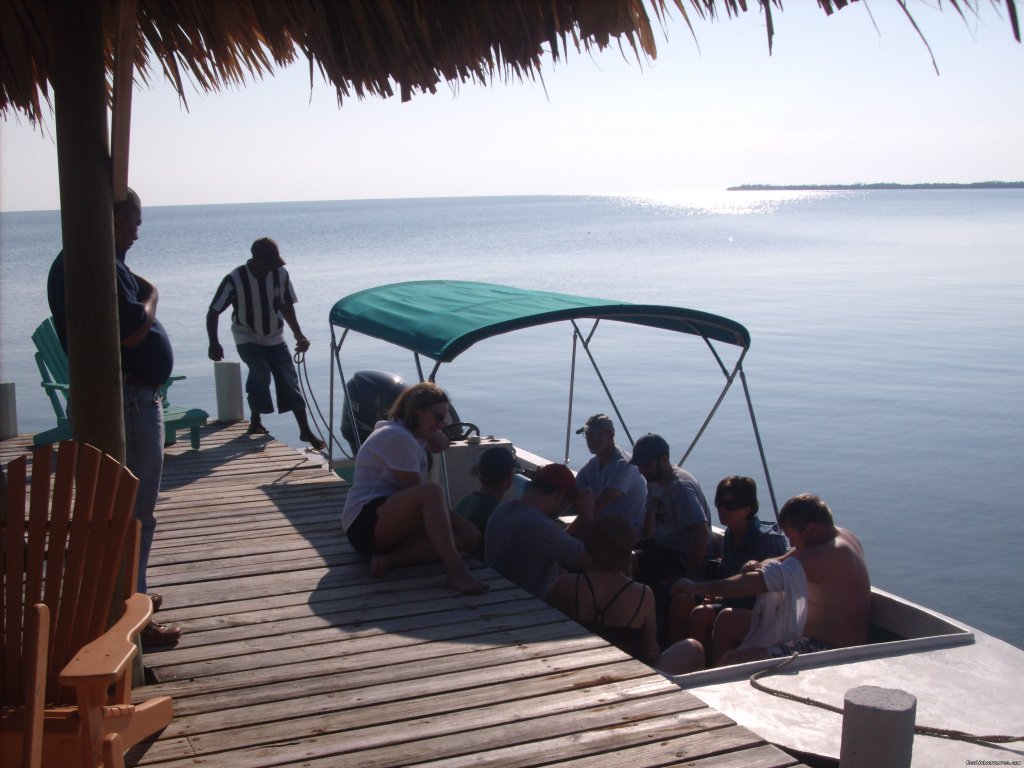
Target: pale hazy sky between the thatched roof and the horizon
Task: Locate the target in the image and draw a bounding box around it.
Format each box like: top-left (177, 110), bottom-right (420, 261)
top-left (0, 0), bottom-right (1024, 210)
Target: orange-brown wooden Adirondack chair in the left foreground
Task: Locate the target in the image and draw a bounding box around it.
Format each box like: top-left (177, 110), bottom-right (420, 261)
top-left (0, 440), bottom-right (173, 768)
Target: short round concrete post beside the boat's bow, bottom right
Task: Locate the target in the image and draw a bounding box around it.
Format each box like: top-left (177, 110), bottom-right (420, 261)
top-left (839, 685), bottom-right (918, 768)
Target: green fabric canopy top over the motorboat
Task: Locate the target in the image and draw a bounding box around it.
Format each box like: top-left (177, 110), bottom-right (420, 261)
top-left (330, 280), bottom-right (751, 362)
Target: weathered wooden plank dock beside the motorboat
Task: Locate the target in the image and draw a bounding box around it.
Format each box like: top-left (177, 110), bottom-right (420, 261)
top-left (4, 424), bottom-right (799, 768)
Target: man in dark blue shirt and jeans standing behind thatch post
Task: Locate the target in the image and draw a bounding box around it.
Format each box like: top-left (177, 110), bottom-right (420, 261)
top-left (46, 189), bottom-right (181, 647)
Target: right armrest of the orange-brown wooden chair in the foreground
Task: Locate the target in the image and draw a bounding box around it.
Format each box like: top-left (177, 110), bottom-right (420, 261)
top-left (60, 592), bottom-right (153, 688)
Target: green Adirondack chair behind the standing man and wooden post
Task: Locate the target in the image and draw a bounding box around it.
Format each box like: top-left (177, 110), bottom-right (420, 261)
top-left (32, 317), bottom-right (210, 451)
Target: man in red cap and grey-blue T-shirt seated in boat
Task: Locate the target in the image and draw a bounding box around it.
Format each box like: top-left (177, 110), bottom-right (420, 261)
top-left (484, 464), bottom-right (594, 597)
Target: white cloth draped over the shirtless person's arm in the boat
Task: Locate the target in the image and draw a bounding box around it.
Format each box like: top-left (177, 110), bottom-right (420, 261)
top-left (739, 556), bottom-right (807, 648)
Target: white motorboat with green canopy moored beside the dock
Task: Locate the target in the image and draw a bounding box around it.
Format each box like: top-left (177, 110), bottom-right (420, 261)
top-left (329, 281), bottom-right (1024, 766)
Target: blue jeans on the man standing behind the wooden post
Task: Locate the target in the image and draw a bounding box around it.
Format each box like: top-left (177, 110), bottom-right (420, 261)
top-left (124, 385), bottom-right (164, 592)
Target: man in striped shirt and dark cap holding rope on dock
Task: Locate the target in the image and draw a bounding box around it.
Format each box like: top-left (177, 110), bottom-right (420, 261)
top-left (206, 238), bottom-right (324, 451)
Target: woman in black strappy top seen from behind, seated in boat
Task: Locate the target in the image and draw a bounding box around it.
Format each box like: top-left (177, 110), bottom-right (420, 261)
top-left (545, 515), bottom-right (660, 665)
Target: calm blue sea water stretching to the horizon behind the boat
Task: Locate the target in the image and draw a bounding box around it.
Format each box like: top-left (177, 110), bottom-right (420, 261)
top-left (0, 190), bottom-right (1024, 646)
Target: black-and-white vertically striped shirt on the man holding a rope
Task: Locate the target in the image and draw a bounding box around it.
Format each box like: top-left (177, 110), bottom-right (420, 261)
top-left (210, 264), bottom-right (298, 346)
